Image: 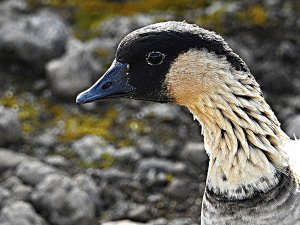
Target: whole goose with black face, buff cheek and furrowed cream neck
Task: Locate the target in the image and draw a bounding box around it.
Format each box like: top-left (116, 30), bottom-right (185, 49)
top-left (76, 22), bottom-right (300, 225)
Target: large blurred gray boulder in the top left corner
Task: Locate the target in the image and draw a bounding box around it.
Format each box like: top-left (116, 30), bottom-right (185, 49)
top-left (0, 11), bottom-right (69, 70)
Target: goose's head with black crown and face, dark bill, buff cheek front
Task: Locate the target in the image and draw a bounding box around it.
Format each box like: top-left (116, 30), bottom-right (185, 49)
top-left (76, 21), bottom-right (248, 105)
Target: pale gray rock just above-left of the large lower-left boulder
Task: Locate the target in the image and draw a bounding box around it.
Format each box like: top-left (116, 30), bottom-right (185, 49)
top-left (16, 161), bottom-right (58, 186)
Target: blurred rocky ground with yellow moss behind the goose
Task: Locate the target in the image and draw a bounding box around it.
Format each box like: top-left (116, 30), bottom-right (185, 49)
top-left (0, 0), bottom-right (300, 225)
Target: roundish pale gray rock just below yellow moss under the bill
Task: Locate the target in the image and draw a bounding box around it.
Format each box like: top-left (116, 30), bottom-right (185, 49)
top-left (72, 136), bottom-right (110, 162)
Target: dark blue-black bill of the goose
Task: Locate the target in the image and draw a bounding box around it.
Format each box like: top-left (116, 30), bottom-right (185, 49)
top-left (76, 60), bottom-right (134, 105)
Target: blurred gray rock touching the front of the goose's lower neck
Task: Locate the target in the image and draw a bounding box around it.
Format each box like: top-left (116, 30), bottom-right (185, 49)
top-left (180, 142), bottom-right (208, 169)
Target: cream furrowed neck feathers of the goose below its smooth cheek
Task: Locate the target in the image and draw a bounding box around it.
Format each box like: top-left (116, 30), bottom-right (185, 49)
top-left (189, 74), bottom-right (288, 199)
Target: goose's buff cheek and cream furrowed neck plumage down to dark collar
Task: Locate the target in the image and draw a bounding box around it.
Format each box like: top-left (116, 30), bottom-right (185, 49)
top-left (167, 50), bottom-right (289, 199)
